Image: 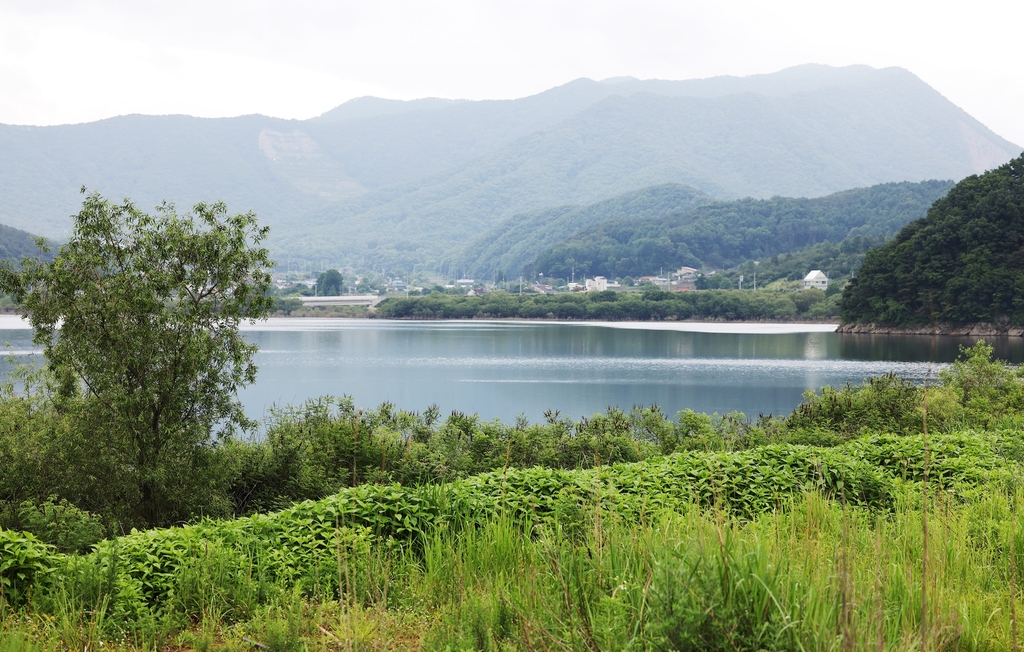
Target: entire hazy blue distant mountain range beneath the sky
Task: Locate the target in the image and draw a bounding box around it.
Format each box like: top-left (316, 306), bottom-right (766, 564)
top-left (0, 66), bottom-right (1020, 273)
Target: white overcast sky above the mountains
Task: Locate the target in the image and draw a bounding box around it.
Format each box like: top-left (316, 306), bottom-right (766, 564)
top-left (0, 0), bottom-right (1024, 145)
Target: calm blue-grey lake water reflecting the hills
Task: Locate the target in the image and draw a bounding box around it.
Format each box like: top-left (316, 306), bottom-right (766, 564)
top-left (8, 316), bottom-right (1024, 421)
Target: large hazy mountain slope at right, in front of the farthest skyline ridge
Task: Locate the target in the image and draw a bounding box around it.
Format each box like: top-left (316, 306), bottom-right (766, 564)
top-left (282, 75), bottom-right (1012, 268)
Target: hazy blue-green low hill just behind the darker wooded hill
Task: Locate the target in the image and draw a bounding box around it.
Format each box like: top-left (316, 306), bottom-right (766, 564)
top-left (441, 183), bottom-right (714, 278)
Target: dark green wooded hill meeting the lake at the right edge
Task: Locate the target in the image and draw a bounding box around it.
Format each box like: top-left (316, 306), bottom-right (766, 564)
top-left (841, 151), bottom-right (1024, 327)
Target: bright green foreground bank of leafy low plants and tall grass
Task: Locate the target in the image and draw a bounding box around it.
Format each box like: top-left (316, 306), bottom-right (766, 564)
top-left (0, 432), bottom-right (1024, 650)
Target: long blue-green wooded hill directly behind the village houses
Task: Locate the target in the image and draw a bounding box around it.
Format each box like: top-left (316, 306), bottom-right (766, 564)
top-left (535, 181), bottom-right (952, 277)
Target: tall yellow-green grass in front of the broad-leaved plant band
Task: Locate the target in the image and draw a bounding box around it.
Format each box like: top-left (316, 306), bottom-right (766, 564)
top-left (0, 485), bottom-right (1024, 651)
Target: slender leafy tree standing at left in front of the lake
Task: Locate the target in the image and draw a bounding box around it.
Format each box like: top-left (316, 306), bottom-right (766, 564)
top-left (0, 193), bottom-right (272, 524)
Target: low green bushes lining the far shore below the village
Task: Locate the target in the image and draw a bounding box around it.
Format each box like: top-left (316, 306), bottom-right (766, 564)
top-left (376, 288), bottom-right (839, 321)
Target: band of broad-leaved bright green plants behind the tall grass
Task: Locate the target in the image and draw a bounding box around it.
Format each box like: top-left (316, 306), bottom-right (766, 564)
top-left (6, 431), bottom-right (1024, 626)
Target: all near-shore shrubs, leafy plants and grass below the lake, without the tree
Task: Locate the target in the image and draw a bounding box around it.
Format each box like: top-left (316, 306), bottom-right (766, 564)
top-left (0, 342), bottom-right (1024, 652)
